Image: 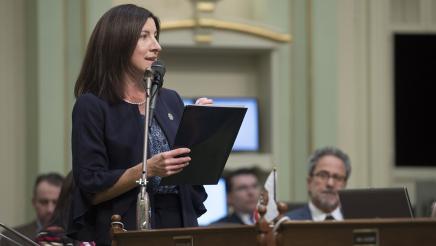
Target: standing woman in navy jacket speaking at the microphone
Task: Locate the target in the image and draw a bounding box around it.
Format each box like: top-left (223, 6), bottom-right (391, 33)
top-left (68, 4), bottom-right (211, 245)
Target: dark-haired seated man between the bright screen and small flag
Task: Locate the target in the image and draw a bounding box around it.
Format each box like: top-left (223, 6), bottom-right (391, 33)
top-left (212, 168), bottom-right (260, 225)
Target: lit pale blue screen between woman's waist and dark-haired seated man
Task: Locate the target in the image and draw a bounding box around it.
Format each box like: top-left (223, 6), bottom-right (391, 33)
top-left (198, 178), bottom-right (227, 226)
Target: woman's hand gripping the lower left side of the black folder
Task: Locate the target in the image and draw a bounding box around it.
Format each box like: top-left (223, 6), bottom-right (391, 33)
top-left (147, 148), bottom-right (191, 177)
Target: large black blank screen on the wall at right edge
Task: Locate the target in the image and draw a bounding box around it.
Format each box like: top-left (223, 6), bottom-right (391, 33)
top-left (391, 33), bottom-right (436, 168)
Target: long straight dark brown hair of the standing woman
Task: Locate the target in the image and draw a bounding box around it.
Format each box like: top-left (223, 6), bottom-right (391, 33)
top-left (74, 4), bottom-right (160, 102)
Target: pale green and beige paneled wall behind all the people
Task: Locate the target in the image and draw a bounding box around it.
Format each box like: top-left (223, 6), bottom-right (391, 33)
top-left (0, 0), bottom-right (436, 225)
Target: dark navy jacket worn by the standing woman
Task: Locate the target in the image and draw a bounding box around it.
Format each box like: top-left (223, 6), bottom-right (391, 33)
top-left (68, 88), bottom-right (207, 245)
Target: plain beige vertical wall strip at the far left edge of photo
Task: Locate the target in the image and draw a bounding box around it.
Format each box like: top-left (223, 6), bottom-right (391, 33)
top-left (0, 0), bottom-right (30, 224)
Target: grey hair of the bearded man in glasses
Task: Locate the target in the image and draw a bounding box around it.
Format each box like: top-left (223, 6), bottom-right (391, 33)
top-left (309, 146), bottom-right (351, 180)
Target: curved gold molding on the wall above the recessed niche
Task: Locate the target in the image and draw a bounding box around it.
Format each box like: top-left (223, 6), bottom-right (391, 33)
top-left (161, 18), bottom-right (292, 43)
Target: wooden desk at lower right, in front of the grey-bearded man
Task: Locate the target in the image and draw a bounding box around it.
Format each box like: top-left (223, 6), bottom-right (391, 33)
top-left (275, 218), bottom-right (436, 246)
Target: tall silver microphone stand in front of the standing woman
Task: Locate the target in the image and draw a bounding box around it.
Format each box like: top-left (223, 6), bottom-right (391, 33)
top-left (136, 70), bottom-right (153, 230)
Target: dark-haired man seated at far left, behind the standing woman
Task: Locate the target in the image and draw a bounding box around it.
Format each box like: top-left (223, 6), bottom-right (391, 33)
top-left (1, 173), bottom-right (63, 246)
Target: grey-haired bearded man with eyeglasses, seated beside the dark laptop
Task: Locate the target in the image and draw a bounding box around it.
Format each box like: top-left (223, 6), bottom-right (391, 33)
top-left (286, 147), bottom-right (351, 221)
